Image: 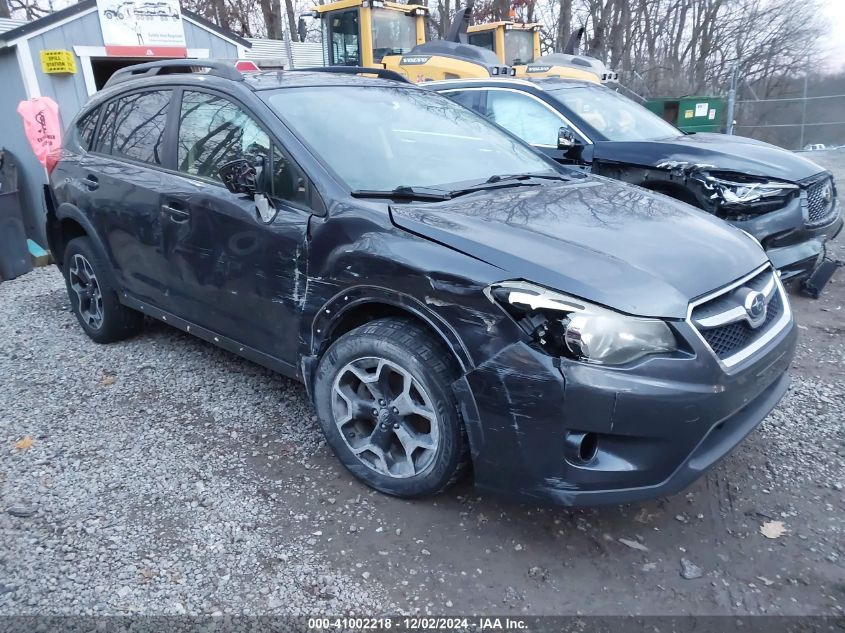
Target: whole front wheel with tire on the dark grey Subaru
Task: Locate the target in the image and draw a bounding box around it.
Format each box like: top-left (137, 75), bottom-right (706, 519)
top-left (314, 318), bottom-right (469, 498)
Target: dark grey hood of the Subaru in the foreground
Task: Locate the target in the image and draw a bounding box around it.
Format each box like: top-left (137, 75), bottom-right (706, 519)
top-left (391, 176), bottom-right (767, 318)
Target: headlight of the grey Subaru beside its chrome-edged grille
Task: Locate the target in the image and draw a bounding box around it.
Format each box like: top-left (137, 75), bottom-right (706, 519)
top-left (487, 281), bottom-right (677, 365)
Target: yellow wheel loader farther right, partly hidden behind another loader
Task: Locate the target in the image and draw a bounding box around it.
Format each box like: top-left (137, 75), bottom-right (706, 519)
top-left (467, 22), bottom-right (618, 83)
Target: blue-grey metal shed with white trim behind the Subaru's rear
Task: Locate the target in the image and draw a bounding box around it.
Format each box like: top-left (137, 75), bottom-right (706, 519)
top-left (0, 0), bottom-right (251, 248)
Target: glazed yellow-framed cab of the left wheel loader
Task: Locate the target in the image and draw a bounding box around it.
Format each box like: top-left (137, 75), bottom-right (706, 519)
top-left (312, 0), bottom-right (428, 67)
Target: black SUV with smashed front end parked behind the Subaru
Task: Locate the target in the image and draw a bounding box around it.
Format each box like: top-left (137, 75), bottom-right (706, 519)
top-left (426, 79), bottom-right (842, 280)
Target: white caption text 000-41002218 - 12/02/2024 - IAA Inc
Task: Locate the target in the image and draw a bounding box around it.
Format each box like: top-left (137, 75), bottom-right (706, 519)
top-left (308, 616), bottom-right (528, 631)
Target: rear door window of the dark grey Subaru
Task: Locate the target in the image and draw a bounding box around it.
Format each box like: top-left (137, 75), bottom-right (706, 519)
top-left (97, 90), bottom-right (173, 165)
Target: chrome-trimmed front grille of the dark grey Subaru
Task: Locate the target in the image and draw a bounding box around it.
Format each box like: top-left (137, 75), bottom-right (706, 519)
top-left (690, 268), bottom-right (788, 365)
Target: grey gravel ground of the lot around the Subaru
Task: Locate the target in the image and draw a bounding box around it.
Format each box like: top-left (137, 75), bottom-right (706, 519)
top-left (0, 154), bottom-right (845, 615)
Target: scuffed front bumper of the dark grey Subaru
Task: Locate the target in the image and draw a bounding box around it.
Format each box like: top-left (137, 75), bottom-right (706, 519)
top-left (456, 308), bottom-right (796, 506)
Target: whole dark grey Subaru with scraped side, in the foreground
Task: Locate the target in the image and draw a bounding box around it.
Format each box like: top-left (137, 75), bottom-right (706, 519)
top-left (47, 60), bottom-right (796, 505)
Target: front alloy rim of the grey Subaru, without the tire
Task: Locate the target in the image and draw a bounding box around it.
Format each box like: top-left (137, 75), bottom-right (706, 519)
top-left (332, 357), bottom-right (440, 478)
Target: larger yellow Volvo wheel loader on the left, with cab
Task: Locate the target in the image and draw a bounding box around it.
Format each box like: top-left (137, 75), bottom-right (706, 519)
top-left (310, 0), bottom-right (514, 83)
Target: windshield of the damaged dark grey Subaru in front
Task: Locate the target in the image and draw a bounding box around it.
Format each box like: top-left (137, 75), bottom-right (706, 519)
top-left (268, 86), bottom-right (556, 191)
